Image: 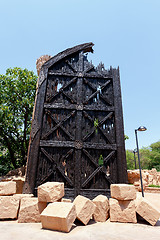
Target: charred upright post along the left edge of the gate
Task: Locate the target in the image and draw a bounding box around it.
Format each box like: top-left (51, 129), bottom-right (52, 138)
top-left (23, 68), bottom-right (47, 193)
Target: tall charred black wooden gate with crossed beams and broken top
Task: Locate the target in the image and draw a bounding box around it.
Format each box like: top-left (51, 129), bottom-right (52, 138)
top-left (24, 43), bottom-right (127, 198)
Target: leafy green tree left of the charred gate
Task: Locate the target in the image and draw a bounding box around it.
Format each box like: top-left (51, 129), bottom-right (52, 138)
top-left (0, 68), bottom-right (37, 172)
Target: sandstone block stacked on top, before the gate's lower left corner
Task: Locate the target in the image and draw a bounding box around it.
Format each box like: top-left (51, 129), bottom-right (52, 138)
top-left (38, 182), bottom-right (64, 202)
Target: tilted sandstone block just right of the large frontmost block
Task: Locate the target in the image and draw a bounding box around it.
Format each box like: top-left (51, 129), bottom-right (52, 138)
top-left (73, 195), bottom-right (96, 225)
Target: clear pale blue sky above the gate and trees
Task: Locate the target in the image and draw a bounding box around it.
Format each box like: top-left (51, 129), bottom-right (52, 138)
top-left (0, 0), bottom-right (160, 149)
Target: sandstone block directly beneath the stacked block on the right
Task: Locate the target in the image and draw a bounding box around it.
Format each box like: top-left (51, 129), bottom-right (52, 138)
top-left (109, 198), bottom-right (137, 223)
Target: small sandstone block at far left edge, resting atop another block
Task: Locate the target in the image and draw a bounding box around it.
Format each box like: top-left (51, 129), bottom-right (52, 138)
top-left (0, 181), bottom-right (16, 196)
